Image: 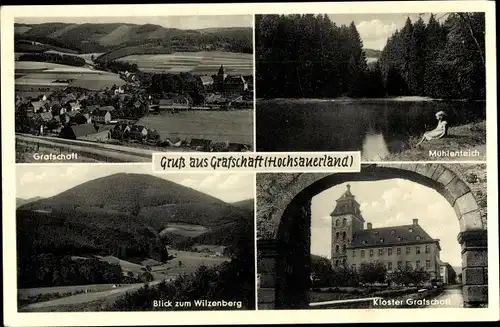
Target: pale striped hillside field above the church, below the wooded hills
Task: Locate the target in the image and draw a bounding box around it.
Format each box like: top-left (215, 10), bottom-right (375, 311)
top-left (119, 51), bottom-right (253, 75)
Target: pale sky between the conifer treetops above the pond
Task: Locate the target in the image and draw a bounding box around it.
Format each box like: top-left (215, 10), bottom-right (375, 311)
top-left (328, 13), bottom-right (442, 50)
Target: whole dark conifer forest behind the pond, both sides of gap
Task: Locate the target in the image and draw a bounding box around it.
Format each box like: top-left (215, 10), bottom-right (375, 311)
top-left (255, 13), bottom-right (485, 99)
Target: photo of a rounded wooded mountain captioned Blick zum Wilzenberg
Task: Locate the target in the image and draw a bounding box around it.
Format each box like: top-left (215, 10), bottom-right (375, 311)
top-left (16, 164), bottom-right (256, 312)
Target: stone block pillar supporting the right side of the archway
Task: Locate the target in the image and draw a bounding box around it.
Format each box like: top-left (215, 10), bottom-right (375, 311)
top-left (458, 229), bottom-right (488, 308)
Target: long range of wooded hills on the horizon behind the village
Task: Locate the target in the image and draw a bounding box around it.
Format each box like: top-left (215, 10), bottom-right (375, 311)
top-left (14, 22), bottom-right (253, 53)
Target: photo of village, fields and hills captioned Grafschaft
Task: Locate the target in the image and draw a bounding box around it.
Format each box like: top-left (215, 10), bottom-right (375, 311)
top-left (14, 15), bottom-right (254, 163)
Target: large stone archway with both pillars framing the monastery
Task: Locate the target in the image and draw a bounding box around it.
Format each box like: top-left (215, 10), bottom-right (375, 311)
top-left (257, 164), bottom-right (488, 309)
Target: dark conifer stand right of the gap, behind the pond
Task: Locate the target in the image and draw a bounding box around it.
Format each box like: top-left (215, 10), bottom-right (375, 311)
top-left (380, 13), bottom-right (486, 99)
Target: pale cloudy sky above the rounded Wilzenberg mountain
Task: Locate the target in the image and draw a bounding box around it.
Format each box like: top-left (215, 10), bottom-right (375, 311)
top-left (16, 164), bottom-right (255, 203)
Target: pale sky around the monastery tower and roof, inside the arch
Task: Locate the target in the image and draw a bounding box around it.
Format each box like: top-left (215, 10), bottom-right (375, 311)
top-left (311, 179), bottom-right (462, 267)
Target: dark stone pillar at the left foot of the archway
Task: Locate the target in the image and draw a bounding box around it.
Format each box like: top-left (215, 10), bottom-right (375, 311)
top-left (257, 240), bottom-right (277, 310)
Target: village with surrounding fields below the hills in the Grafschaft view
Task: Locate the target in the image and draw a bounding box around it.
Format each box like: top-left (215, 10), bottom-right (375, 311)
top-left (15, 23), bottom-right (254, 160)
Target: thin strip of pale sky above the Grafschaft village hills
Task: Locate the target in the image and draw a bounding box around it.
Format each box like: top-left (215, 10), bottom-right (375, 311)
top-left (16, 15), bottom-right (253, 29)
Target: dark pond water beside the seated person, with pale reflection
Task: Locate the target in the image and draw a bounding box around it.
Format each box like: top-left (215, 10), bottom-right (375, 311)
top-left (256, 99), bottom-right (486, 160)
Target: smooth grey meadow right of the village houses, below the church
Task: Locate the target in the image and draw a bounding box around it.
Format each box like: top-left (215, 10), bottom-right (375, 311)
top-left (137, 110), bottom-right (253, 147)
